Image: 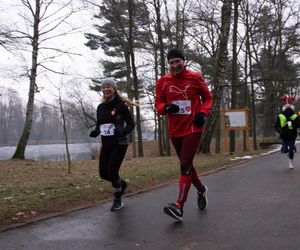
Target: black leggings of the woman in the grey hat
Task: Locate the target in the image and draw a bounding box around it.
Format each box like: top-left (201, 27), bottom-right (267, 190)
top-left (99, 144), bottom-right (128, 188)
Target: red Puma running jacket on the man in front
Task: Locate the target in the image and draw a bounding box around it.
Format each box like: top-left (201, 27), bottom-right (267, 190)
top-left (155, 69), bottom-right (213, 137)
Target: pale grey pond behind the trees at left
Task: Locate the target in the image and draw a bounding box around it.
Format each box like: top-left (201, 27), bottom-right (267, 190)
top-left (0, 143), bottom-right (101, 161)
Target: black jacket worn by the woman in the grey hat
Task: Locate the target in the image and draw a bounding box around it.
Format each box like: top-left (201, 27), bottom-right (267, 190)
top-left (95, 96), bottom-right (135, 146)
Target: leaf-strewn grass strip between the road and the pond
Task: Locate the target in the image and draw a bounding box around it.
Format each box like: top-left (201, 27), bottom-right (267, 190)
top-left (0, 147), bottom-right (268, 226)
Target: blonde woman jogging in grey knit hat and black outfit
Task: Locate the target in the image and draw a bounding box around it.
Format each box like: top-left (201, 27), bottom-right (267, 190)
top-left (90, 77), bottom-right (135, 211)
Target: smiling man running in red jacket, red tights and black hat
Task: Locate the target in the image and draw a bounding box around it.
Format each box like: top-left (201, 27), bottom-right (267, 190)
top-left (155, 48), bottom-right (213, 221)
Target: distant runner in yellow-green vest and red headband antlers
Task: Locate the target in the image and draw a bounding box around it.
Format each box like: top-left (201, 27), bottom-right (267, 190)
top-left (274, 96), bottom-right (300, 169)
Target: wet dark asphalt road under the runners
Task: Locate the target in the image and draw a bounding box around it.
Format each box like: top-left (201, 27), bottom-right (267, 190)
top-left (0, 152), bottom-right (300, 250)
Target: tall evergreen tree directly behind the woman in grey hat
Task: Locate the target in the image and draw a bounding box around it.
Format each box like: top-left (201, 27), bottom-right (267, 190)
top-left (86, 0), bottom-right (149, 156)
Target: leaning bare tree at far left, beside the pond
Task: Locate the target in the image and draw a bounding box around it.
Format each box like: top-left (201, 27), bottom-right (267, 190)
top-left (10, 0), bottom-right (79, 159)
